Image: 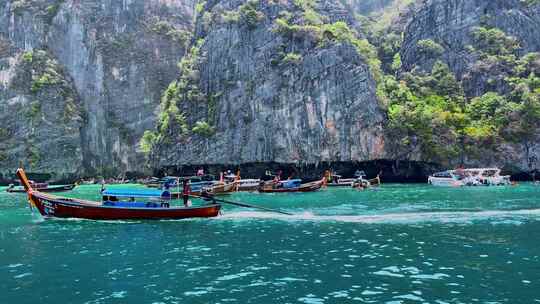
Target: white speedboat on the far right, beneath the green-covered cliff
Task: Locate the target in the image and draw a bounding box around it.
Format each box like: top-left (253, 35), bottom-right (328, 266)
top-left (428, 168), bottom-right (511, 187)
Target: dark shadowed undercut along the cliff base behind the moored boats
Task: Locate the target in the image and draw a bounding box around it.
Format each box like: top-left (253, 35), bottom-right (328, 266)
top-left (0, 160), bottom-right (540, 186)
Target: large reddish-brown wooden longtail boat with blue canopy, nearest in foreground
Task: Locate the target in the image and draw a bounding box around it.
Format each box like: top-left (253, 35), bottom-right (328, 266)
top-left (17, 169), bottom-right (221, 220)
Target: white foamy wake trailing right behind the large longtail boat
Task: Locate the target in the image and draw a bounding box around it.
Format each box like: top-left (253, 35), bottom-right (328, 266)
top-left (220, 209), bottom-right (540, 224)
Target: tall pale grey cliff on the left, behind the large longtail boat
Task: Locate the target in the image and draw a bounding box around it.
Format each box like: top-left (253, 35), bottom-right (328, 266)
top-left (0, 0), bottom-right (195, 176)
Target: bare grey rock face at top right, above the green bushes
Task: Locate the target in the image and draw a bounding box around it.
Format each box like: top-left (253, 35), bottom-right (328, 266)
top-left (401, 0), bottom-right (540, 90)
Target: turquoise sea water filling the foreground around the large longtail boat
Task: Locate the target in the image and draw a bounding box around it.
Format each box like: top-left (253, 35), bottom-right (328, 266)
top-left (0, 184), bottom-right (540, 304)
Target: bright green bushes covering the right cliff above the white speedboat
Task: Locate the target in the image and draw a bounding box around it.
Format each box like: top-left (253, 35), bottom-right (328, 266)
top-left (384, 27), bottom-right (540, 163)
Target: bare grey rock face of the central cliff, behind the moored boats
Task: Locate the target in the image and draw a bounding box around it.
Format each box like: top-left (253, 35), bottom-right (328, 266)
top-left (152, 1), bottom-right (384, 165)
